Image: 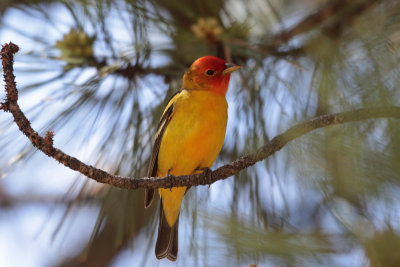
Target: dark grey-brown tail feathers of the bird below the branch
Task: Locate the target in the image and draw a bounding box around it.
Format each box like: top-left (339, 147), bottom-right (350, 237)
top-left (156, 200), bottom-right (179, 261)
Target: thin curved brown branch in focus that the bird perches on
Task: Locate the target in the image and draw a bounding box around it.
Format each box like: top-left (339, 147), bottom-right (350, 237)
top-left (0, 42), bottom-right (400, 189)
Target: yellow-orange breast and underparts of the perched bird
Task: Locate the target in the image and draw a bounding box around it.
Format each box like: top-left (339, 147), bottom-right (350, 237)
top-left (157, 90), bottom-right (228, 226)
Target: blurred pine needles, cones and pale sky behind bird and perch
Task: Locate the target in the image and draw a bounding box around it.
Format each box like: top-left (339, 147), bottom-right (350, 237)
top-left (0, 0), bottom-right (400, 267)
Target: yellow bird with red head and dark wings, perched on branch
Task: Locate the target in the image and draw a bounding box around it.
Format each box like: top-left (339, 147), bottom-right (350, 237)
top-left (145, 56), bottom-right (241, 261)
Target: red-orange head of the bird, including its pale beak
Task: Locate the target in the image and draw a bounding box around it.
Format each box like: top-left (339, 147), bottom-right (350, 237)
top-left (183, 56), bottom-right (240, 95)
